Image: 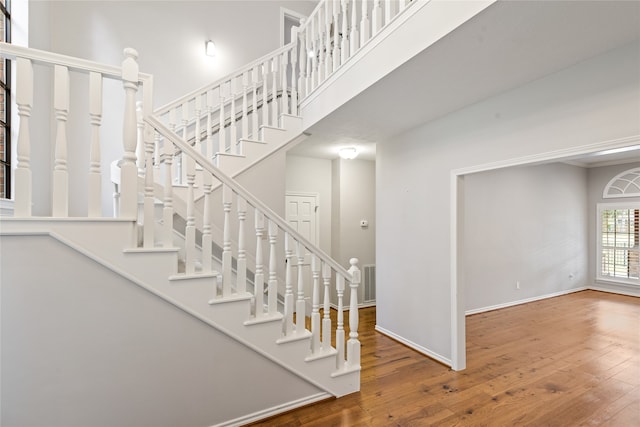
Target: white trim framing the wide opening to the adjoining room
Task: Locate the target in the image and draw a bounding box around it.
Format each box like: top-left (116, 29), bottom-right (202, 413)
top-left (449, 135), bottom-right (640, 374)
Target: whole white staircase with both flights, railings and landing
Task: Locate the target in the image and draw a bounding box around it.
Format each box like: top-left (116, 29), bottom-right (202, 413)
top-left (0, 0), bottom-right (464, 425)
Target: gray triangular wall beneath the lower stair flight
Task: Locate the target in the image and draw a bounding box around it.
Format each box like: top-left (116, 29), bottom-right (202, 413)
top-left (0, 236), bottom-right (319, 427)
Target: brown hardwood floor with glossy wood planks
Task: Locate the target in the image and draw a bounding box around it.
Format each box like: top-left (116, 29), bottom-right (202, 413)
top-left (252, 291), bottom-right (640, 427)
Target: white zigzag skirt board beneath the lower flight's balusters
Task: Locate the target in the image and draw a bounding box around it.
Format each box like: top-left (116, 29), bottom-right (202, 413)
top-left (0, 218), bottom-right (360, 397)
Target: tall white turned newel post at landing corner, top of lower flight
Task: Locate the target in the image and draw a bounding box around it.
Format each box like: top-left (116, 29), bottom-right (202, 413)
top-left (120, 48), bottom-right (138, 219)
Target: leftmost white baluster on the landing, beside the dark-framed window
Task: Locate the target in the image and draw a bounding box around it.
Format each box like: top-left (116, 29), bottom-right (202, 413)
top-left (14, 58), bottom-right (33, 217)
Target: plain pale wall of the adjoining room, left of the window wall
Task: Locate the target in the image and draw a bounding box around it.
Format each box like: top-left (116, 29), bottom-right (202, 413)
top-left (463, 163), bottom-right (588, 311)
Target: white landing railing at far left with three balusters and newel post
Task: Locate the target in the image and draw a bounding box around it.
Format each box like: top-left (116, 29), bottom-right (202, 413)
top-left (0, 43), bottom-right (153, 219)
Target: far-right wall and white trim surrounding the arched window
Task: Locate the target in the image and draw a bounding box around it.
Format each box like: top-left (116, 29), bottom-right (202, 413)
top-left (588, 162), bottom-right (640, 296)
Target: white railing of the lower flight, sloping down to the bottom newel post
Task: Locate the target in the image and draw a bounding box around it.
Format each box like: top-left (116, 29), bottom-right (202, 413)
top-left (144, 116), bottom-right (361, 376)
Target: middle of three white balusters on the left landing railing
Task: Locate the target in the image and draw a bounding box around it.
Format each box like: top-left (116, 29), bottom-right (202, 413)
top-left (52, 65), bottom-right (69, 217)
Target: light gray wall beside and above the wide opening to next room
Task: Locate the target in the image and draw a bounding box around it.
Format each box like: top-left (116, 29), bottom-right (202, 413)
top-left (376, 43), bottom-right (640, 362)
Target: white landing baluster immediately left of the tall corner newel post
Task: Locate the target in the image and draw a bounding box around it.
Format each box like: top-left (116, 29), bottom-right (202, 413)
top-left (87, 73), bottom-right (102, 218)
